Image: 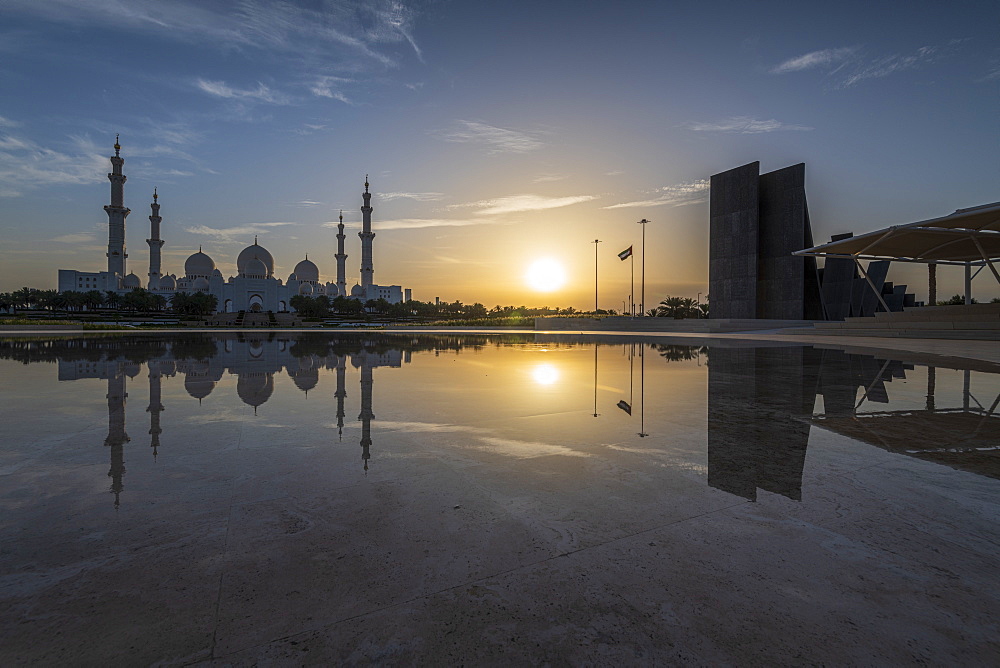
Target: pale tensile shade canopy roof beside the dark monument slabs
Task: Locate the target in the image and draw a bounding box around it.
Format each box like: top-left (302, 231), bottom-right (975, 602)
top-left (794, 202), bottom-right (1000, 265)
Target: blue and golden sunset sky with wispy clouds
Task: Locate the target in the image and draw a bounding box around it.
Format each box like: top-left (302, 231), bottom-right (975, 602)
top-left (0, 0), bottom-right (1000, 309)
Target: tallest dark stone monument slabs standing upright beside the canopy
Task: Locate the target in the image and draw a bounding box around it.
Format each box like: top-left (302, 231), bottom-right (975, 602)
top-left (708, 162), bottom-right (823, 320)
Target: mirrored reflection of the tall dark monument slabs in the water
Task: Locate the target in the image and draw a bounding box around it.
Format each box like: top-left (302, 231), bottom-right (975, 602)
top-left (708, 347), bottom-right (819, 501)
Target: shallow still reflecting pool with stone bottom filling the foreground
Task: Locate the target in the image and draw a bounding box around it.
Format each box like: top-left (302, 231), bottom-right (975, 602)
top-left (0, 332), bottom-right (1000, 665)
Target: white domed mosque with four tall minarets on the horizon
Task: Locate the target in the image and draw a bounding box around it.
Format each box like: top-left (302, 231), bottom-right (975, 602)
top-left (59, 138), bottom-right (410, 313)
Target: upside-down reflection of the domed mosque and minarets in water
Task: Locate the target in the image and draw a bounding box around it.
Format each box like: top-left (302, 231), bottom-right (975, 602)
top-left (50, 334), bottom-right (422, 508)
